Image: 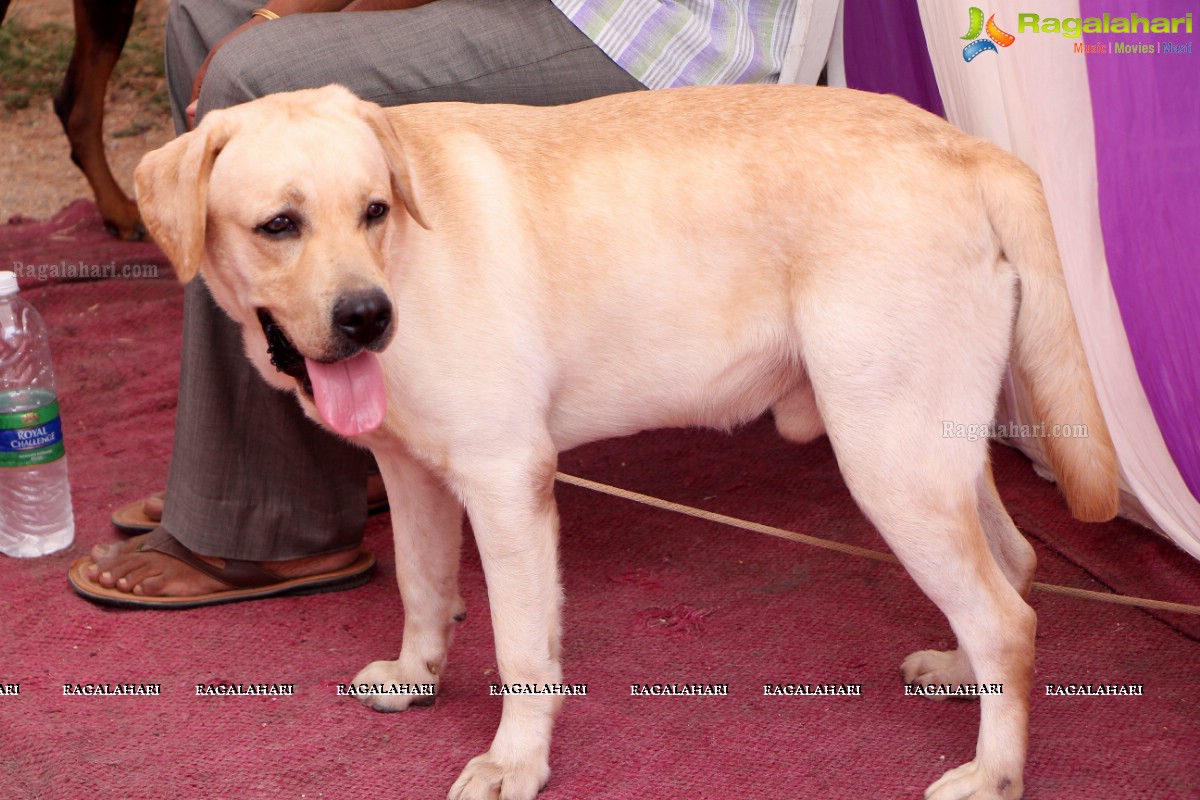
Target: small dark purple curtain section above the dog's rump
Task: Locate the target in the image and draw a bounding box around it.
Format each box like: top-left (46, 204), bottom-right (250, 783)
top-left (842, 0), bottom-right (946, 116)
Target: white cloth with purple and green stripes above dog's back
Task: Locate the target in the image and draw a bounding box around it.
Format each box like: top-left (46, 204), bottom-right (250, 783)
top-left (553, 0), bottom-right (798, 89)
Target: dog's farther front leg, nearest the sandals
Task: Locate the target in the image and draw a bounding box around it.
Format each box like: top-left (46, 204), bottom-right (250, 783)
top-left (354, 450), bottom-right (466, 711)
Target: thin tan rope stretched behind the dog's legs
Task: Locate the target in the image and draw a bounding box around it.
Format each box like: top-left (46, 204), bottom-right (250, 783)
top-left (556, 473), bottom-right (1200, 614)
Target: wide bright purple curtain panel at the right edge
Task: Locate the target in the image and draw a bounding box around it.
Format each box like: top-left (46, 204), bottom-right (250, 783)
top-left (1089, 0), bottom-right (1200, 500)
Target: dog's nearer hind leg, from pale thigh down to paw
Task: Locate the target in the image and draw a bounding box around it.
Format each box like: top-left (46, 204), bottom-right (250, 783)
top-left (798, 266), bottom-right (1037, 800)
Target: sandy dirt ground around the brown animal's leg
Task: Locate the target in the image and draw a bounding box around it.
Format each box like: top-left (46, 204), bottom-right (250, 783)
top-left (0, 0), bottom-right (174, 224)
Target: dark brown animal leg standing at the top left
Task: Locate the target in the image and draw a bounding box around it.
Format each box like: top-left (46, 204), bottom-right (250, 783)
top-left (54, 0), bottom-right (146, 241)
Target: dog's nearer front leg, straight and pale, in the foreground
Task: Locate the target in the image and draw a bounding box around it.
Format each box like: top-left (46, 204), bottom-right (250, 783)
top-left (450, 456), bottom-right (563, 800)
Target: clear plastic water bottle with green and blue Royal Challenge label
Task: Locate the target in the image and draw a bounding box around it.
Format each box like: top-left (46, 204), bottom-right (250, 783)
top-left (0, 272), bottom-right (74, 557)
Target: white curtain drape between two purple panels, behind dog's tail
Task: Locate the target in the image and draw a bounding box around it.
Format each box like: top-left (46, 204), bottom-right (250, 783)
top-left (918, 0), bottom-right (1200, 558)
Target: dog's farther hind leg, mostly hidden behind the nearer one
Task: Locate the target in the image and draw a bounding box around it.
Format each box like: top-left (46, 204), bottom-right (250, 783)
top-left (900, 464), bottom-right (1037, 699)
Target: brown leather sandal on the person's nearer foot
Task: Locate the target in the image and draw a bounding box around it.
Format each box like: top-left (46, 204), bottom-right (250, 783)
top-left (67, 528), bottom-right (376, 608)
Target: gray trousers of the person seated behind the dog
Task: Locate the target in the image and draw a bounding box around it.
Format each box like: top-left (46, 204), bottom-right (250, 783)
top-left (163, 0), bottom-right (643, 560)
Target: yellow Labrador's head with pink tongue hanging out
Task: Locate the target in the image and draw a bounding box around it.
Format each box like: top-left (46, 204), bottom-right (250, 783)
top-left (134, 86), bottom-right (428, 435)
